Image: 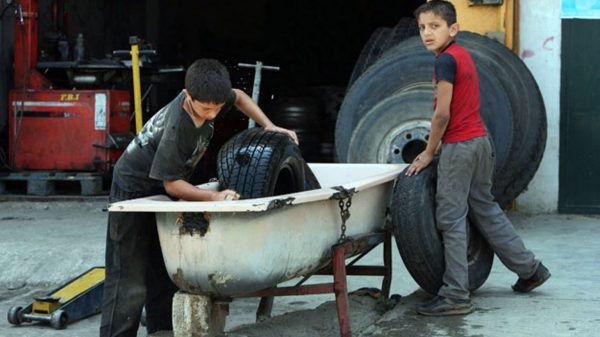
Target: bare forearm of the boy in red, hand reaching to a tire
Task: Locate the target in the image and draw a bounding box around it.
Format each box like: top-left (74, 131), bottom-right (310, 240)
top-left (406, 81), bottom-right (453, 176)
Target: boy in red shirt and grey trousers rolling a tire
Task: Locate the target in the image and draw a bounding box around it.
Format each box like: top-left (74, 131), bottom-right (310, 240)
top-left (406, 0), bottom-right (550, 316)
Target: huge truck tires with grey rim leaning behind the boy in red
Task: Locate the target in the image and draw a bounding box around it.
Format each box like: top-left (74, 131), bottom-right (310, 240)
top-left (335, 32), bottom-right (546, 207)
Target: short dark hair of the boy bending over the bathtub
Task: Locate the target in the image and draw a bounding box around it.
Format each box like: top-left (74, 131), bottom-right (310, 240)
top-left (185, 59), bottom-right (231, 103)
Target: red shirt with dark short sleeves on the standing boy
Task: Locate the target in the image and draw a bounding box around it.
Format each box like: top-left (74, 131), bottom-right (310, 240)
top-left (433, 41), bottom-right (487, 143)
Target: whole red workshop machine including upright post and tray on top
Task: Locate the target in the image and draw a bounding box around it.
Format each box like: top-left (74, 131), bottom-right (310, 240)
top-left (8, 0), bottom-right (133, 171)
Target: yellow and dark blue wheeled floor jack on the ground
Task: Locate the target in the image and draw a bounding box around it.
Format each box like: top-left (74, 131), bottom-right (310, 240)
top-left (8, 267), bottom-right (105, 329)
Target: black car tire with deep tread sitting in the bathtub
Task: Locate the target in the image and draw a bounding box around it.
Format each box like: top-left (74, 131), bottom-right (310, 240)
top-left (217, 128), bottom-right (319, 199)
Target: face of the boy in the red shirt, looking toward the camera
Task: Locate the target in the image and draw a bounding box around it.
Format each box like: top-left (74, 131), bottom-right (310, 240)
top-left (418, 11), bottom-right (458, 54)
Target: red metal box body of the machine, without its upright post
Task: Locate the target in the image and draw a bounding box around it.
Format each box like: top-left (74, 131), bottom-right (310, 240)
top-left (8, 89), bottom-right (132, 171)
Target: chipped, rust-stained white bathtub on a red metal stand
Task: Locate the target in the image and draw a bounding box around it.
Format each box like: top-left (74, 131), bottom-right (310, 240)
top-left (109, 164), bottom-right (407, 336)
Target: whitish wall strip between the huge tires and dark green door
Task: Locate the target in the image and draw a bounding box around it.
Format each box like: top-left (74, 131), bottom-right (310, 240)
top-left (517, 0), bottom-right (561, 213)
